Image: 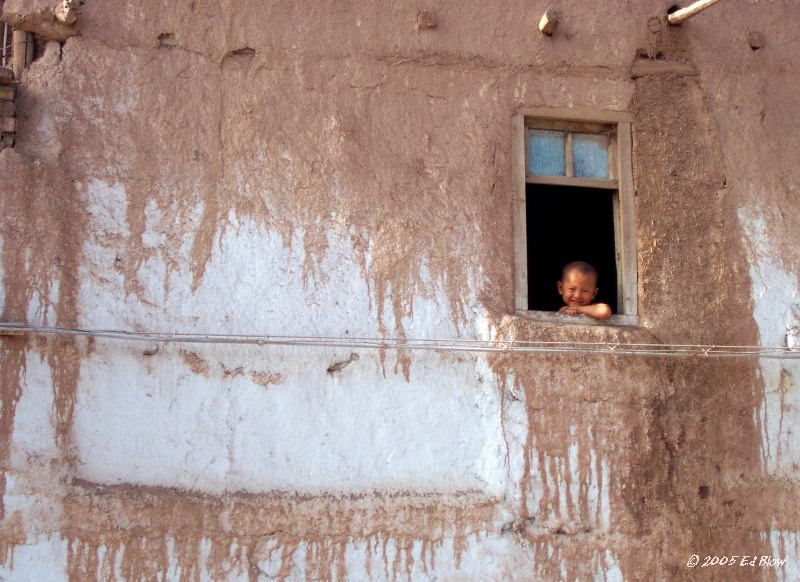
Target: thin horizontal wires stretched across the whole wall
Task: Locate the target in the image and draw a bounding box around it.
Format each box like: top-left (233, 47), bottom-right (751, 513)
top-left (0, 323), bottom-right (800, 360)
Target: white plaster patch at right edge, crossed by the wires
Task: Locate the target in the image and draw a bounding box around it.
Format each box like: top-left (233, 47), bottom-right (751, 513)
top-left (739, 210), bottom-right (800, 477)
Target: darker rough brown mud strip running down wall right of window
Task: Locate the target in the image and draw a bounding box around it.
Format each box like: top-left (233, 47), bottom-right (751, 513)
top-left (627, 24), bottom-right (770, 576)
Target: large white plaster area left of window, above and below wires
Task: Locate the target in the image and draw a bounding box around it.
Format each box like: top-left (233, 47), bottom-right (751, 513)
top-left (74, 212), bottom-right (506, 494)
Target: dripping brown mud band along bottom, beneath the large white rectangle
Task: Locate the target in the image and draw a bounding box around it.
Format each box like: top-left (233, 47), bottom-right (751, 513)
top-left (64, 483), bottom-right (497, 581)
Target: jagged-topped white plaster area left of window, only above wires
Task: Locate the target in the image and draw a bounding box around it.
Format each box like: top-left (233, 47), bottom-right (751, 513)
top-left (80, 194), bottom-right (483, 338)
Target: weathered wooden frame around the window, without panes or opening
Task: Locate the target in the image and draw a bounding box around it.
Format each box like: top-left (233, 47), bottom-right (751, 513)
top-left (511, 107), bottom-right (639, 325)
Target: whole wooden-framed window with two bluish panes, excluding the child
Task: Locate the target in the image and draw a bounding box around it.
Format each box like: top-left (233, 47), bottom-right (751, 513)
top-left (512, 109), bottom-right (637, 325)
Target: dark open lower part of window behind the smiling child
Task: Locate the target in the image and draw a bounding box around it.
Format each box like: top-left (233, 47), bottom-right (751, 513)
top-left (525, 184), bottom-right (620, 313)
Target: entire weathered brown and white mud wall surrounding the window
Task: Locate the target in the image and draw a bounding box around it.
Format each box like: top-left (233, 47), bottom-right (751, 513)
top-left (0, 0), bottom-right (800, 581)
